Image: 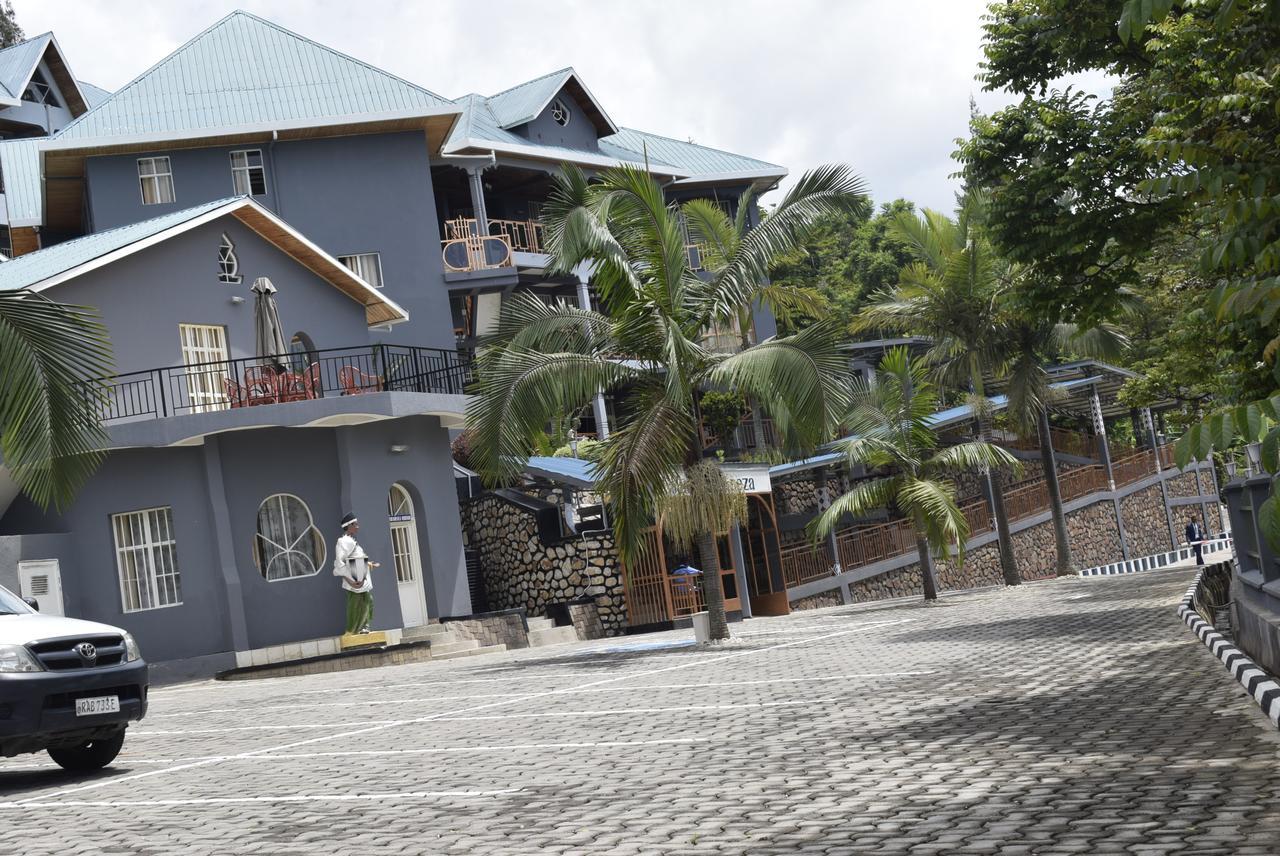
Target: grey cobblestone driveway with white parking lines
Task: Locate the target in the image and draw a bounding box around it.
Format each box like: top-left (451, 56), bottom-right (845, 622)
top-left (0, 562), bottom-right (1280, 856)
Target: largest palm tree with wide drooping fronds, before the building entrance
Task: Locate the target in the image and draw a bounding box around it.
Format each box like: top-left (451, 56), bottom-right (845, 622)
top-left (467, 166), bottom-right (867, 638)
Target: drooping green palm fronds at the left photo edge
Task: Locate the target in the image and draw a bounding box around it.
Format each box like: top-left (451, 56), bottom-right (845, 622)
top-left (0, 289), bottom-right (111, 511)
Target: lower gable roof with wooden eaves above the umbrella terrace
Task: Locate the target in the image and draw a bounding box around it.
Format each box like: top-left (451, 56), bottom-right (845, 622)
top-left (0, 196), bottom-right (408, 326)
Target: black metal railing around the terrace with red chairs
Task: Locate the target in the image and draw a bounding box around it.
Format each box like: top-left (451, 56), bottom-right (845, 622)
top-left (90, 344), bottom-right (471, 424)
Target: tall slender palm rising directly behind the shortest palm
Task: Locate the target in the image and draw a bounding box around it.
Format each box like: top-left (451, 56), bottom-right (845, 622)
top-left (855, 200), bottom-right (1021, 586)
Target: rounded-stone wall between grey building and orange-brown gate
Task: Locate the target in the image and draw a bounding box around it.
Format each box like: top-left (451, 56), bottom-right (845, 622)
top-left (462, 496), bottom-right (627, 636)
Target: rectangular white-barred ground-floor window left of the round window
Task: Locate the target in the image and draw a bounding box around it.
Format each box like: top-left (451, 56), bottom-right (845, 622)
top-left (111, 508), bottom-right (182, 613)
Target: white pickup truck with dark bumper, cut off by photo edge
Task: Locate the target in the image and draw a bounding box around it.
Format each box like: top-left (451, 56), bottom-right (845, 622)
top-left (0, 586), bottom-right (147, 772)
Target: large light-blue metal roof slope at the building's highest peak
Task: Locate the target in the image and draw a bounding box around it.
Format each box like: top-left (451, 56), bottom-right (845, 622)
top-left (56, 12), bottom-right (452, 141)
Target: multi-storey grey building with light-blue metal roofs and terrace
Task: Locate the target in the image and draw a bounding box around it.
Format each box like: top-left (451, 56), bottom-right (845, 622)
top-left (0, 12), bottom-right (786, 673)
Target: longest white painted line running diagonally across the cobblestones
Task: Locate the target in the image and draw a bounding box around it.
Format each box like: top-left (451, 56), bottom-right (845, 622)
top-left (0, 618), bottom-right (916, 807)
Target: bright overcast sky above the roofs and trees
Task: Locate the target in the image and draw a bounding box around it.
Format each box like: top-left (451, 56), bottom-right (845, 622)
top-left (22, 0), bottom-right (1059, 211)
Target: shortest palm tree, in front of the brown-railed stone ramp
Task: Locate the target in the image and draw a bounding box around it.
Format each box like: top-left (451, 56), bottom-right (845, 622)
top-left (810, 348), bottom-right (1019, 600)
